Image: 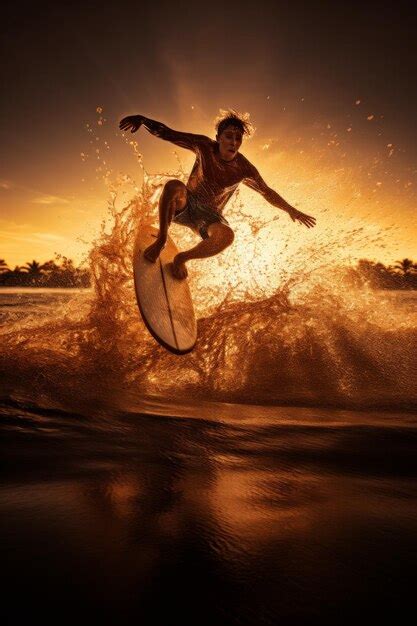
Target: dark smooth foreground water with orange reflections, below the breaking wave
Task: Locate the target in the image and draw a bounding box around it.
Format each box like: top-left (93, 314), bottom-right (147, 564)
top-left (0, 400), bottom-right (417, 626)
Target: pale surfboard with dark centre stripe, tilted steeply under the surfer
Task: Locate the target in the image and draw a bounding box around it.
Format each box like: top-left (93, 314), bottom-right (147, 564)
top-left (133, 225), bottom-right (197, 354)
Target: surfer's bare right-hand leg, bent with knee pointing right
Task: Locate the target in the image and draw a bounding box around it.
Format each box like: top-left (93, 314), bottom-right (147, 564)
top-left (172, 222), bottom-right (234, 278)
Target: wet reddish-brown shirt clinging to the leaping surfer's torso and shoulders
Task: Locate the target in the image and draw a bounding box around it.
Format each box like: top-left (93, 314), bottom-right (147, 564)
top-left (154, 124), bottom-right (269, 214)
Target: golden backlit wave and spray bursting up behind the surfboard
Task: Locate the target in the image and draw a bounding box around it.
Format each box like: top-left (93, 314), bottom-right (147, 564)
top-left (0, 146), bottom-right (417, 407)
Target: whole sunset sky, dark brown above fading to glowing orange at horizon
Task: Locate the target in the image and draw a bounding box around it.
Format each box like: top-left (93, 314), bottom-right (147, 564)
top-left (0, 0), bottom-right (417, 266)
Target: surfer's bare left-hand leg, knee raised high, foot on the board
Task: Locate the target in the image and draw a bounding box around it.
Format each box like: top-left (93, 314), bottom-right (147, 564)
top-left (144, 179), bottom-right (187, 263)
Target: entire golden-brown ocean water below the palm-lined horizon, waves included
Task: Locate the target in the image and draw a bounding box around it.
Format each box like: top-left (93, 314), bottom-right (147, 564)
top-left (0, 285), bottom-right (417, 626)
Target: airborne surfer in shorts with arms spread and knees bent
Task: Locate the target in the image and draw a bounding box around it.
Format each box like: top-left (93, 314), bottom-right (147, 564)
top-left (119, 110), bottom-right (316, 278)
